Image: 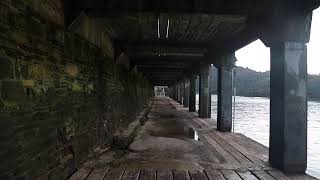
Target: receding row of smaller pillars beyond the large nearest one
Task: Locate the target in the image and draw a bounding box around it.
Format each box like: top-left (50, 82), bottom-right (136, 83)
top-left (171, 57), bottom-right (235, 129)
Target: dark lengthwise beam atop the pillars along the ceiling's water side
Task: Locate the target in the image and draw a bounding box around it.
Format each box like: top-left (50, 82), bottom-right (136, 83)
top-left (204, 0), bottom-right (320, 65)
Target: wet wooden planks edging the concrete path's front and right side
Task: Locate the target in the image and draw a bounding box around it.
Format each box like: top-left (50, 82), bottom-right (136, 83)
top-left (70, 98), bottom-right (316, 180)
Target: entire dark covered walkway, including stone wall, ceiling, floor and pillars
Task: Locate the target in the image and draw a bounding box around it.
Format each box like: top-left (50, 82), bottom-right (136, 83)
top-left (0, 0), bottom-right (320, 180)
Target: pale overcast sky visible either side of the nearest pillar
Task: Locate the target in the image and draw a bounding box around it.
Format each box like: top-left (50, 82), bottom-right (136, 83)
top-left (236, 8), bottom-right (320, 74)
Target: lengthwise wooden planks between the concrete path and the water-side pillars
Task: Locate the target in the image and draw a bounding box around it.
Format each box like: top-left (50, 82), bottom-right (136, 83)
top-left (184, 104), bottom-right (270, 167)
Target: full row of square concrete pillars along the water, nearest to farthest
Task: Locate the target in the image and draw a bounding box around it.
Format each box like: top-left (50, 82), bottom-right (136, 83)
top-left (171, 37), bottom-right (307, 172)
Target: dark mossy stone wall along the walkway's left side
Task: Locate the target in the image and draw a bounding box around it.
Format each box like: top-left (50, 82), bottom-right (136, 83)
top-left (0, 0), bottom-right (152, 179)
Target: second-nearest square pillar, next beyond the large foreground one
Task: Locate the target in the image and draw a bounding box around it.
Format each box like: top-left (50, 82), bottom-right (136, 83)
top-left (217, 66), bottom-right (232, 132)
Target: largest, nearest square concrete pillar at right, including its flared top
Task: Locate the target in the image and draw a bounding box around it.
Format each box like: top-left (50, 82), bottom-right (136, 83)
top-left (261, 9), bottom-right (312, 173)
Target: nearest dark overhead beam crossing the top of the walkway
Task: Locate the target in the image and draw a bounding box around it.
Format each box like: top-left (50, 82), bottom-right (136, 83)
top-left (77, 0), bottom-right (259, 17)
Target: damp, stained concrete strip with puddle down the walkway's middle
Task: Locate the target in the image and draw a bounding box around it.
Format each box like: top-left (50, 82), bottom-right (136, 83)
top-left (81, 98), bottom-right (226, 170)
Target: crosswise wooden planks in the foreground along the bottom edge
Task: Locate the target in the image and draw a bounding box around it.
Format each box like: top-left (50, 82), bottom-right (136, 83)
top-left (70, 168), bottom-right (288, 180)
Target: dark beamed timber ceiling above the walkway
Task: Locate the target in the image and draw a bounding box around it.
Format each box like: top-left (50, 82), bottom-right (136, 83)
top-left (65, 0), bottom-right (319, 85)
